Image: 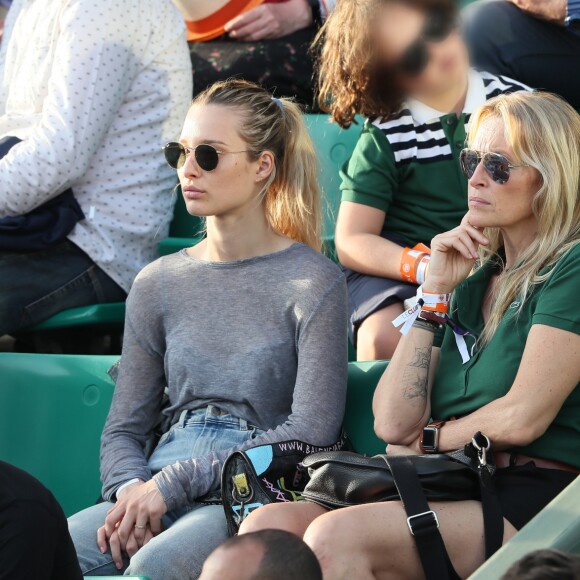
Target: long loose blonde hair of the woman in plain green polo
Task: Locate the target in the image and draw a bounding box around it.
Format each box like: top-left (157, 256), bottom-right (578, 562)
top-left (468, 92), bottom-right (580, 345)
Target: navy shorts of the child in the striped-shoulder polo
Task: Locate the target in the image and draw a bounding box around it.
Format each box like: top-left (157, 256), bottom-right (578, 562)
top-left (343, 268), bottom-right (417, 348)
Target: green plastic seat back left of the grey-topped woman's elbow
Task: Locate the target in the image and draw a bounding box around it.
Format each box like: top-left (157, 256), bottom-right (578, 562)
top-left (0, 353), bottom-right (119, 516)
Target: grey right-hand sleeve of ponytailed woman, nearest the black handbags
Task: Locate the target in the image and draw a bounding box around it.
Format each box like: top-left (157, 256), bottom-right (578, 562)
top-left (154, 274), bottom-right (348, 510)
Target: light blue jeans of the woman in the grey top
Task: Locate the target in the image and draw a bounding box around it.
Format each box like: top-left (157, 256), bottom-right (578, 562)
top-left (69, 405), bottom-right (261, 580)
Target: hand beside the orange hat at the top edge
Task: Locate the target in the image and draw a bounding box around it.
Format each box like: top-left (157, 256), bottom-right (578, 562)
top-left (225, 0), bottom-right (312, 42)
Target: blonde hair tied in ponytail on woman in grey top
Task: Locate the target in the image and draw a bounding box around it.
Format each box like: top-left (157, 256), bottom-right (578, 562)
top-left (193, 79), bottom-right (322, 251)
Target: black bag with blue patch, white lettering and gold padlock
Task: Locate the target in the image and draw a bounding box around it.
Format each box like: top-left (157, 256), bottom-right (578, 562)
top-left (221, 432), bottom-right (349, 536)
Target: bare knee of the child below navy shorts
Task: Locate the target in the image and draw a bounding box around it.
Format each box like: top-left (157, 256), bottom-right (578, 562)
top-left (356, 302), bottom-right (403, 361)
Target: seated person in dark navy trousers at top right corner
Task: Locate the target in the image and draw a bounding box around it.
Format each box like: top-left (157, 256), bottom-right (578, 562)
top-left (464, 0), bottom-right (580, 109)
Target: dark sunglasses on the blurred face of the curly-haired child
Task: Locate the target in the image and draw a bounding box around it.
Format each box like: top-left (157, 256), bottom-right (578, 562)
top-left (396, 10), bottom-right (457, 76)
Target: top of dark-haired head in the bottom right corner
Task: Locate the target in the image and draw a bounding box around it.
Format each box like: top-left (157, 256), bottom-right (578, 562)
top-left (501, 550), bottom-right (580, 580)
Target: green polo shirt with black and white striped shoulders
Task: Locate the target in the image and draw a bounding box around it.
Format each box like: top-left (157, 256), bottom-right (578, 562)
top-left (341, 71), bottom-right (528, 247)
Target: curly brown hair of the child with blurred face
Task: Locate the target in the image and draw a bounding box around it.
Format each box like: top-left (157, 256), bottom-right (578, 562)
top-left (313, 0), bottom-right (455, 128)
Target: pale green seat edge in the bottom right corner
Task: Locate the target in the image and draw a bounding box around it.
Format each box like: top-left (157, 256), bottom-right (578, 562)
top-left (470, 477), bottom-right (580, 580)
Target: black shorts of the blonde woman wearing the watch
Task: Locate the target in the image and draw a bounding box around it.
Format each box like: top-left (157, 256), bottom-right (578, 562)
top-left (495, 462), bottom-right (577, 530)
